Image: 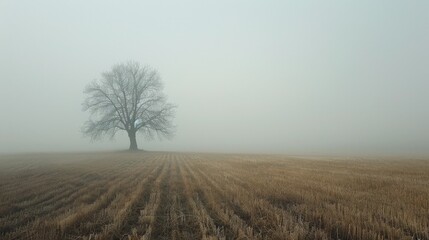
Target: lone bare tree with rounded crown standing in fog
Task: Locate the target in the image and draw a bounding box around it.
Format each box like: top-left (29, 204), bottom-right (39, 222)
top-left (82, 62), bottom-right (176, 150)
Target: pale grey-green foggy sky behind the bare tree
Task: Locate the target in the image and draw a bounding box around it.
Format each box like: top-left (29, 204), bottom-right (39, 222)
top-left (0, 0), bottom-right (429, 155)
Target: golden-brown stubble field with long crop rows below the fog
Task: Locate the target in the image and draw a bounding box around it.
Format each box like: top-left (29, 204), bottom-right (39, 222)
top-left (0, 152), bottom-right (429, 240)
